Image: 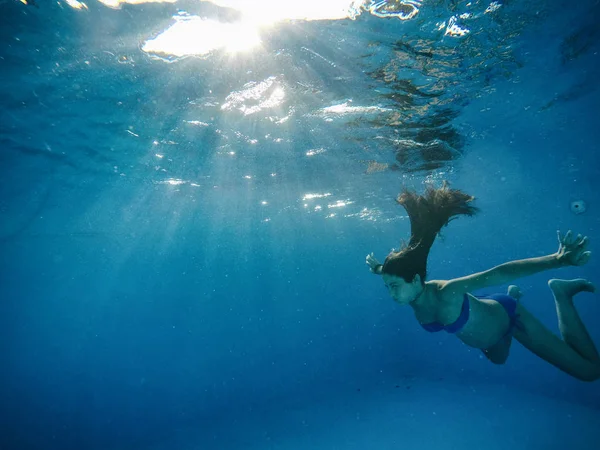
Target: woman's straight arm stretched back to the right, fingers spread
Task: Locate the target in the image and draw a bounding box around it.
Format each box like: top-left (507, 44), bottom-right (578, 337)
top-left (442, 231), bottom-right (591, 294)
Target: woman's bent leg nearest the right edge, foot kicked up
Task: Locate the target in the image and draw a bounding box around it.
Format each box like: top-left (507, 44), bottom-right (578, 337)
top-left (514, 279), bottom-right (600, 381)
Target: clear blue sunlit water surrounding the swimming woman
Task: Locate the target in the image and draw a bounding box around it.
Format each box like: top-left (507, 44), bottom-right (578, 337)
top-left (0, 0), bottom-right (600, 450)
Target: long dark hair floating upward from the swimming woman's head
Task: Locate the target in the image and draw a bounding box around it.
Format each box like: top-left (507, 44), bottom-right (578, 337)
top-left (382, 181), bottom-right (479, 283)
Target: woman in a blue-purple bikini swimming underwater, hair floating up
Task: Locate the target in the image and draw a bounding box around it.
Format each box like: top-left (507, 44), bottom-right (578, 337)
top-left (366, 183), bottom-right (600, 381)
